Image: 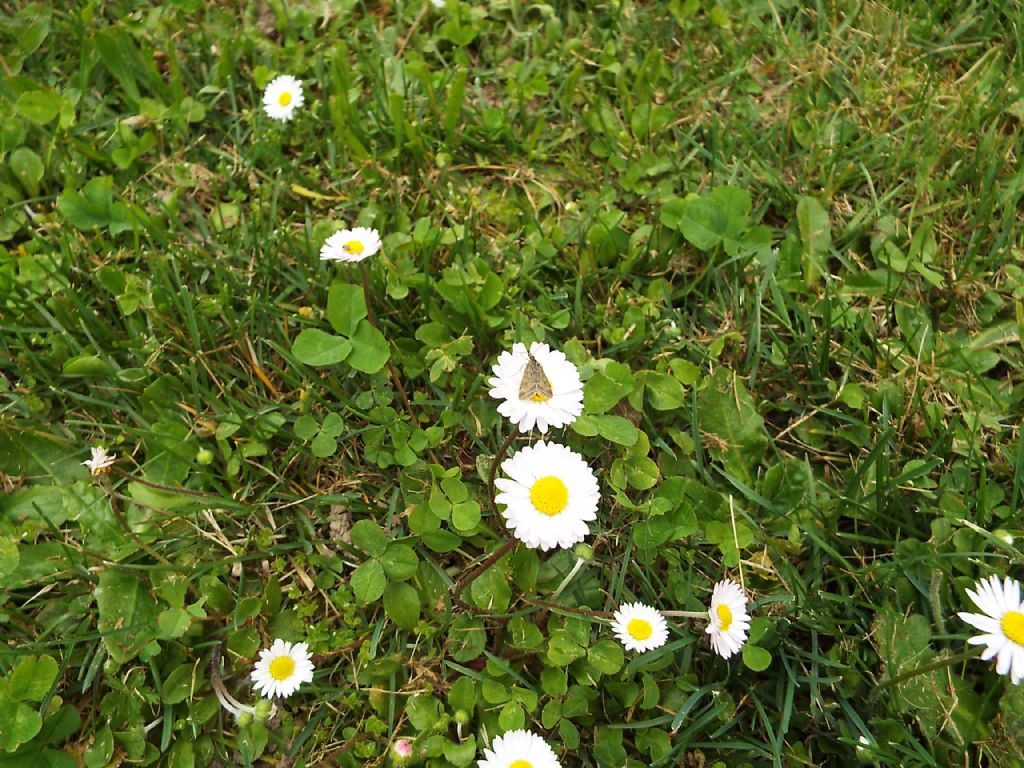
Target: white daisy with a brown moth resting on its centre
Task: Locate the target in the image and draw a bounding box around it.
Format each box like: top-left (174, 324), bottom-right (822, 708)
top-left (489, 341), bottom-right (583, 433)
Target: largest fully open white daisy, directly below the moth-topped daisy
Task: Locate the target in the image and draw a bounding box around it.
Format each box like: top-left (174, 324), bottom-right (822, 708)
top-left (495, 440), bottom-right (601, 552)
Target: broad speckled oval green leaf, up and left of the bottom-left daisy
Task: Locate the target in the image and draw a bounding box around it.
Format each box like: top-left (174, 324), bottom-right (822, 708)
top-left (94, 570), bottom-right (157, 664)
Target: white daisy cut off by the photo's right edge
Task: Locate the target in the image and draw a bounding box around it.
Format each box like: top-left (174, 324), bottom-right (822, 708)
top-left (956, 577), bottom-right (1024, 685)
